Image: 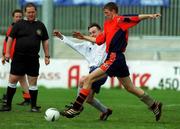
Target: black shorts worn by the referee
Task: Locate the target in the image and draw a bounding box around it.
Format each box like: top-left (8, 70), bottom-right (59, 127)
top-left (10, 54), bottom-right (39, 77)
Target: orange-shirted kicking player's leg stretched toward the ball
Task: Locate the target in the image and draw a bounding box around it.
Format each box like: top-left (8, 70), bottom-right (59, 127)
top-left (61, 68), bottom-right (105, 118)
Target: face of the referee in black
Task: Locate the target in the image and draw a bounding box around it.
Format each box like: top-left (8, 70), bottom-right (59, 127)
top-left (25, 7), bottom-right (36, 21)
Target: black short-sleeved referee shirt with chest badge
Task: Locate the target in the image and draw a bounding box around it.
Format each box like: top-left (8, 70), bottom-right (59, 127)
top-left (10, 19), bottom-right (49, 56)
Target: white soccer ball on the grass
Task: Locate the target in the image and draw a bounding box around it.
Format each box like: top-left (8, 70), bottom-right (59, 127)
top-left (44, 108), bottom-right (60, 121)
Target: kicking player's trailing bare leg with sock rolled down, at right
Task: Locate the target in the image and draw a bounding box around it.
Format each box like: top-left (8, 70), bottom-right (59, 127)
top-left (118, 76), bottom-right (162, 121)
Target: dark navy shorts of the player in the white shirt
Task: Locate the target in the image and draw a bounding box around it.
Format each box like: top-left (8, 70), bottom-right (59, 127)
top-left (89, 66), bottom-right (107, 94)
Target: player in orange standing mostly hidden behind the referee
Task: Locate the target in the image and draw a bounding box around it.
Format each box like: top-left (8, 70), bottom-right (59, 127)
top-left (2, 9), bottom-right (30, 105)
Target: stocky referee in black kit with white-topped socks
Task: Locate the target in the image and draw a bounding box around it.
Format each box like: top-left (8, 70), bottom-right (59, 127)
top-left (0, 3), bottom-right (50, 112)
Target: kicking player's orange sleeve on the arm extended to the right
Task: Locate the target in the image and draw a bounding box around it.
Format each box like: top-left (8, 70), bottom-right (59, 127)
top-left (117, 15), bottom-right (140, 30)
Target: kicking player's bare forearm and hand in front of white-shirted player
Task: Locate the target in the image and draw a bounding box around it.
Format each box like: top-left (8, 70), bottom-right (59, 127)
top-left (73, 32), bottom-right (96, 43)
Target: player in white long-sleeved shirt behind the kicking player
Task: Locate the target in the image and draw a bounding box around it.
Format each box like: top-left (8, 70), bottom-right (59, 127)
top-left (53, 23), bottom-right (112, 120)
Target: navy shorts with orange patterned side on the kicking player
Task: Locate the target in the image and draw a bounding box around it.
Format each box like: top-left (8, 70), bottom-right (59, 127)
top-left (100, 52), bottom-right (129, 77)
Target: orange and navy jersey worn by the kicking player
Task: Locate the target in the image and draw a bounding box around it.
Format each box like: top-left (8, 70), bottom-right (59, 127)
top-left (96, 15), bottom-right (140, 53)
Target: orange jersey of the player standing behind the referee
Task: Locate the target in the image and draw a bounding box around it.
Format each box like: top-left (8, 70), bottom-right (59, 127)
top-left (3, 24), bottom-right (16, 59)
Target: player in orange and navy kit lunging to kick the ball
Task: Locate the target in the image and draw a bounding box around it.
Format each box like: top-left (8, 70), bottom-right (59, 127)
top-left (61, 2), bottom-right (162, 121)
